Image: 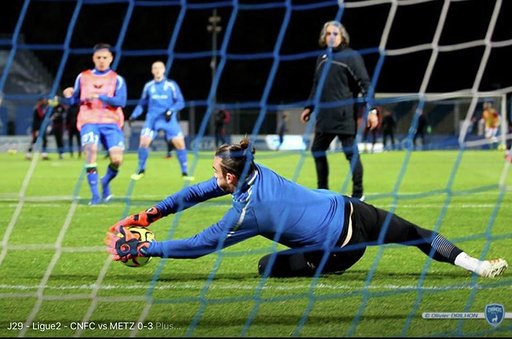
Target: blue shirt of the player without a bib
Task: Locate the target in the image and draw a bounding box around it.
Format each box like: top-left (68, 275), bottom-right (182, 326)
top-left (130, 79), bottom-right (185, 125)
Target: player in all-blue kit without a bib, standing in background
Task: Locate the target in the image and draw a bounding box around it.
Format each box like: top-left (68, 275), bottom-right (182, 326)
top-left (130, 61), bottom-right (194, 180)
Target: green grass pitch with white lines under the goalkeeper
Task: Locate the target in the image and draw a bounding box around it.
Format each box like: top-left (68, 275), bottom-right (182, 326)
top-left (0, 151), bottom-right (512, 337)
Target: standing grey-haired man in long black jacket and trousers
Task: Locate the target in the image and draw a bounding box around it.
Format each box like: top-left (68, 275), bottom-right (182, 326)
top-left (300, 21), bottom-right (378, 200)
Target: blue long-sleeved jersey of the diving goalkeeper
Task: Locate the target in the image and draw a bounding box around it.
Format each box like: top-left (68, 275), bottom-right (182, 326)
top-left (148, 164), bottom-right (345, 258)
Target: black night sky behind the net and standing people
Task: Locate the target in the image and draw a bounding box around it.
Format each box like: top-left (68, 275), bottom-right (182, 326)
top-left (0, 0), bottom-right (512, 138)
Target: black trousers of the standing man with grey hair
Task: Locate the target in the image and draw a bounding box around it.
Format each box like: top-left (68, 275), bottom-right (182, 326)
top-left (311, 132), bottom-right (363, 198)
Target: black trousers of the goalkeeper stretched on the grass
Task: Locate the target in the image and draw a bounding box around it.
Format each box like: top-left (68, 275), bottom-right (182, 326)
top-left (258, 200), bottom-right (462, 277)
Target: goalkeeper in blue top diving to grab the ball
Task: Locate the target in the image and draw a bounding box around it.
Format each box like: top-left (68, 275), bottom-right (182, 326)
top-left (105, 138), bottom-right (508, 277)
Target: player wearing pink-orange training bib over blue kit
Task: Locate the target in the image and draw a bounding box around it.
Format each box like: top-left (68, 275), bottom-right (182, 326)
top-left (63, 43), bottom-right (126, 205)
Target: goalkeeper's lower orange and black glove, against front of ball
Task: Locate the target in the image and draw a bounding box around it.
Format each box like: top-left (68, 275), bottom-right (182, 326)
top-left (105, 226), bottom-right (149, 261)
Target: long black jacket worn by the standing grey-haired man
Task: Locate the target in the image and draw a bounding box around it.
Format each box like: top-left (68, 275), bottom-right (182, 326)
top-left (307, 48), bottom-right (370, 134)
